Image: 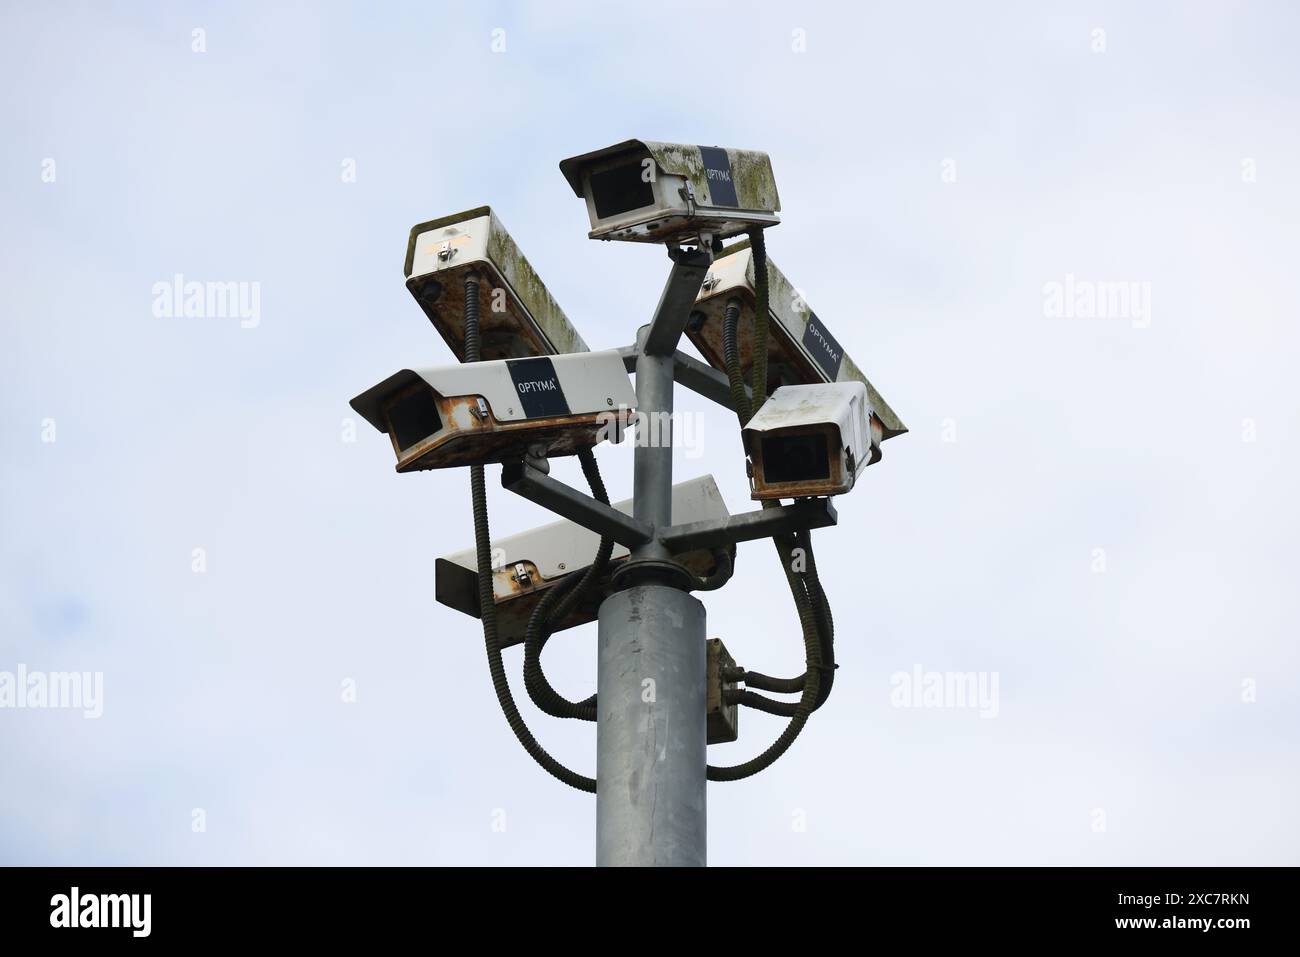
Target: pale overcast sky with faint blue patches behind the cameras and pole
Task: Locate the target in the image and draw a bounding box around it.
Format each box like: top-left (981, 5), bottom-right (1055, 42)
top-left (0, 3), bottom-right (1300, 865)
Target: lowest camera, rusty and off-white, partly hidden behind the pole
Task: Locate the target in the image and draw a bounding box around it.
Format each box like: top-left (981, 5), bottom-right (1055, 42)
top-left (434, 475), bottom-right (735, 646)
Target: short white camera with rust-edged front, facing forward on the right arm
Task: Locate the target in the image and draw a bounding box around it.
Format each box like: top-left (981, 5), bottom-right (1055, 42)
top-left (741, 381), bottom-right (883, 501)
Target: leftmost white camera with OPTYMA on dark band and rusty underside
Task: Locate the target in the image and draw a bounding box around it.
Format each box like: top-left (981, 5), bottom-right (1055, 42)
top-left (352, 350), bottom-right (636, 472)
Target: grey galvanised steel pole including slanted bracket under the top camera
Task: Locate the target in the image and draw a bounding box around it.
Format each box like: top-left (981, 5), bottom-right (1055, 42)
top-left (595, 251), bottom-right (712, 866)
